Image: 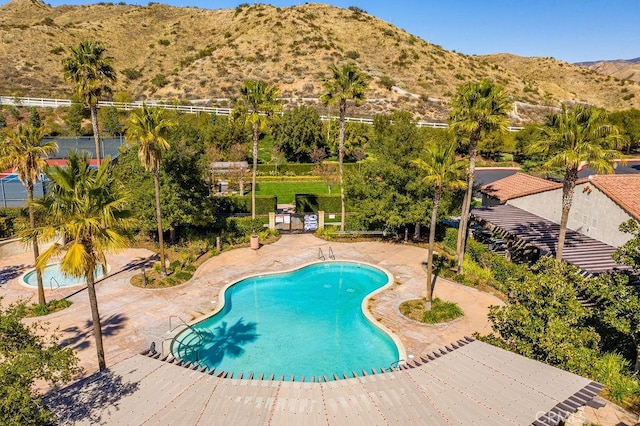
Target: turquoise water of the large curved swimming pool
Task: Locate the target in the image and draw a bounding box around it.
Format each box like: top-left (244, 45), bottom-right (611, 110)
top-left (171, 262), bottom-right (398, 380)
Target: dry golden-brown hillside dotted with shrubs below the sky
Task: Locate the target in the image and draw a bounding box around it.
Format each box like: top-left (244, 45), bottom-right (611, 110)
top-left (0, 0), bottom-right (640, 122)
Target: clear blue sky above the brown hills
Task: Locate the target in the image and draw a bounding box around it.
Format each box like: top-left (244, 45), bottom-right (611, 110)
top-left (0, 0), bottom-right (640, 63)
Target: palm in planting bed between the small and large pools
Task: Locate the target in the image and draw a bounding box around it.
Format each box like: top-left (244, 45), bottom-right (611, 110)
top-left (126, 104), bottom-right (176, 278)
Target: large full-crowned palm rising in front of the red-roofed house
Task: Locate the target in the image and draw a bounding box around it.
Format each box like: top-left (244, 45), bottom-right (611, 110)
top-left (530, 105), bottom-right (624, 261)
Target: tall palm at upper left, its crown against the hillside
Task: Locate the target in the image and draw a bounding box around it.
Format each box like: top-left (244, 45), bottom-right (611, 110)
top-left (62, 40), bottom-right (116, 165)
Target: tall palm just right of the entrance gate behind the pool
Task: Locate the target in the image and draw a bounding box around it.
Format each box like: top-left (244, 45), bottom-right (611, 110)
top-left (320, 64), bottom-right (369, 232)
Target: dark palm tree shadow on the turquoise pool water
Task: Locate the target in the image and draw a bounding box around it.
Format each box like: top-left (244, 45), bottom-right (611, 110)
top-left (181, 318), bottom-right (259, 367)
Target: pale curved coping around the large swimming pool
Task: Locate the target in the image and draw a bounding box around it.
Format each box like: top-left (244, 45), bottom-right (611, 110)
top-left (168, 260), bottom-right (407, 370)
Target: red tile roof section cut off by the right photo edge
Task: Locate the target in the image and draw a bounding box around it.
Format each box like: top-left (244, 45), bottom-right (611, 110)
top-left (588, 174), bottom-right (640, 220)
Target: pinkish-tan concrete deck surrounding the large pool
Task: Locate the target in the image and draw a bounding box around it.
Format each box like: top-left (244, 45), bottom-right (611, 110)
top-left (0, 235), bottom-right (636, 424)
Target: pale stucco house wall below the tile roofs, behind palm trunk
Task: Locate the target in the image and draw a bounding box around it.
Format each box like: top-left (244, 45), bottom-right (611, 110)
top-left (507, 182), bottom-right (631, 247)
